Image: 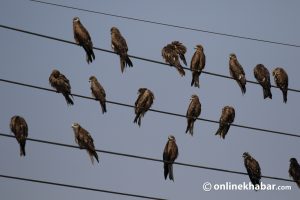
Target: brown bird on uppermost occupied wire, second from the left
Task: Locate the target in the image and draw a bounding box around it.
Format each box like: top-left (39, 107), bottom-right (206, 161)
top-left (110, 27), bottom-right (133, 73)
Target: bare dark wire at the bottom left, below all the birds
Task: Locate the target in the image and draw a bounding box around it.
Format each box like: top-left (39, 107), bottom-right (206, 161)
top-left (0, 174), bottom-right (166, 200)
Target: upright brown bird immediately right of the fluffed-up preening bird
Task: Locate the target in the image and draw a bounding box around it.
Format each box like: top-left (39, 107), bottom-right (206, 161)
top-left (190, 44), bottom-right (205, 88)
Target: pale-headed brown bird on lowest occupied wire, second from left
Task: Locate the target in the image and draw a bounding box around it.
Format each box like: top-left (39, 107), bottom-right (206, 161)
top-left (72, 123), bottom-right (99, 164)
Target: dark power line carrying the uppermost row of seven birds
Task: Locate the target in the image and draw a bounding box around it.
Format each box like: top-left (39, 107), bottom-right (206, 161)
top-left (0, 24), bottom-right (300, 93)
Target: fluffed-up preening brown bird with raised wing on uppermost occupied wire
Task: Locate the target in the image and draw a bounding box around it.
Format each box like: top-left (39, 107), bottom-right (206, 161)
top-left (161, 44), bottom-right (185, 76)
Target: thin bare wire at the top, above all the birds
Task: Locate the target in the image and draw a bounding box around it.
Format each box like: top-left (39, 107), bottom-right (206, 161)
top-left (29, 0), bottom-right (300, 48)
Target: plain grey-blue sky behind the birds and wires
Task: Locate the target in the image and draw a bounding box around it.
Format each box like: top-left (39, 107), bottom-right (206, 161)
top-left (0, 0), bottom-right (300, 200)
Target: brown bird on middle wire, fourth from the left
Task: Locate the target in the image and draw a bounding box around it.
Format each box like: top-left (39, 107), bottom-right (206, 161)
top-left (185, 94), bottom-right (201, 136)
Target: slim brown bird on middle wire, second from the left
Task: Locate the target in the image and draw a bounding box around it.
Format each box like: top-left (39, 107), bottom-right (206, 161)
top-left (89, 76), bottom-right (106, 114)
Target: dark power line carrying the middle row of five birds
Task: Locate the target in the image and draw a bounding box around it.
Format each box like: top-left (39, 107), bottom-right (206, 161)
top-left (0, 78), bottom-right (300, 138)
